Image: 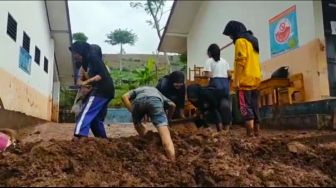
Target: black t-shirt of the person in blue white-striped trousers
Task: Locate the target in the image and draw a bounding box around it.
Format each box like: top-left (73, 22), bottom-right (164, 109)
top-left (87, 54), bottom-right (114, 98)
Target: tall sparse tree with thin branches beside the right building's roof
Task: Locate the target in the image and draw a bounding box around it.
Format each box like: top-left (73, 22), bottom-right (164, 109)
top-left (130, 0), bottom-right (171, 72)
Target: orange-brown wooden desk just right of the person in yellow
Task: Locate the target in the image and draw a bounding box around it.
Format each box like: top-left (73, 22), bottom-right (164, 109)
top-left (258, 78), bottom-right (290, 106)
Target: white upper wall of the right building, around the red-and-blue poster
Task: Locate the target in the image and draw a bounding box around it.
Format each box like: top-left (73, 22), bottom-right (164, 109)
top-left (187, 1), bottom-right (323, 73)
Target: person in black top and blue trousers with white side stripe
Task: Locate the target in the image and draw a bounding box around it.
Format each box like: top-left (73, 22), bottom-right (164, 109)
top-left (69, 41), bottom-right (114, 138)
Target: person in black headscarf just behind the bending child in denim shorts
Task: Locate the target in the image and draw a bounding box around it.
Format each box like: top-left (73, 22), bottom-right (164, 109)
top-left (156, 71), bottom-right (186, 118)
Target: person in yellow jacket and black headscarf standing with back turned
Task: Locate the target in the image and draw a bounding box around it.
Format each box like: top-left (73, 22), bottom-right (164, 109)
top-left (223, 20), bottom-right (262, 136)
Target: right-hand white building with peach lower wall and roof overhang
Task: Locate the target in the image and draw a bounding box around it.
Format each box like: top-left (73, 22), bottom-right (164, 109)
top-left (158, 0), bottom-right (336, 100)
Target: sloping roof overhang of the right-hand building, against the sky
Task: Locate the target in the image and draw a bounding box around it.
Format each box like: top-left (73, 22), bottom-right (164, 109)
top-left (158, 0), bottom-right (203, 53)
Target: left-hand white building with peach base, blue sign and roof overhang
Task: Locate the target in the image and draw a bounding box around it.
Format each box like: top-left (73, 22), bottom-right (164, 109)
top-left (0, 0), bottom-right (74, 121)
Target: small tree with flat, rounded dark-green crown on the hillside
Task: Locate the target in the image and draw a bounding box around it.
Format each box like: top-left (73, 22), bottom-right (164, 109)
top-left (105, 28), bottom-right (138, 72)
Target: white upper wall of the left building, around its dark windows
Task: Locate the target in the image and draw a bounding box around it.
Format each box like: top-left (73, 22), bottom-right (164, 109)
top-left (0, 1), bottom-right (54, 97)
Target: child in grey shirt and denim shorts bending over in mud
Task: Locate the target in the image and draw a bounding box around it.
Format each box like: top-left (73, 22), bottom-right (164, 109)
top-left (122, 86), bottom-right (175, 160)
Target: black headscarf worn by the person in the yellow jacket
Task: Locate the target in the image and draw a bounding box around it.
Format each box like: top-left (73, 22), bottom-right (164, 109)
top-left (223, 20), bottom-right (259, 53)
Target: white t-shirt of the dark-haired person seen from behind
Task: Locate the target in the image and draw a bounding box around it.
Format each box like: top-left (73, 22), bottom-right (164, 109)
top-left (205, 58), bottom-right (230, 78)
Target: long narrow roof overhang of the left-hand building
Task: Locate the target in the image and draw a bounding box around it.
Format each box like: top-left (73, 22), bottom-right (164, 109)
top-left (44, 0), bottom-right (75, 86)
